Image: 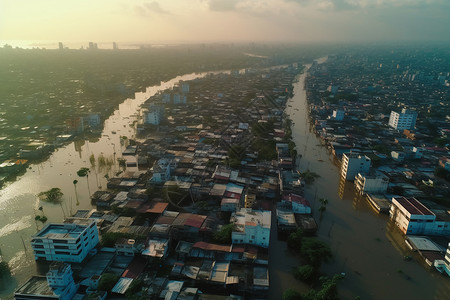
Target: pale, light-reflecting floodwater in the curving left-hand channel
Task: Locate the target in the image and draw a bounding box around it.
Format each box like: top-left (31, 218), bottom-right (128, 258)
top-left (0, 71), bottom-right (221, 299)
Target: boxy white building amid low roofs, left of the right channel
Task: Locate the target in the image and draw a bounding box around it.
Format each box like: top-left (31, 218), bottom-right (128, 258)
top-left (230, 208), bottom-right (271, 248)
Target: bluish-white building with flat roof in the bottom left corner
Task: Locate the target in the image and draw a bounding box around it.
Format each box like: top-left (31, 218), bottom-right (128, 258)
top-left (14, 263), bottom-right (78, 300)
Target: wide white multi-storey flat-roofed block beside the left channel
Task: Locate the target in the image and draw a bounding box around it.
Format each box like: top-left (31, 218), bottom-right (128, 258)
top-left (31, 220), bottom-right (99, 263)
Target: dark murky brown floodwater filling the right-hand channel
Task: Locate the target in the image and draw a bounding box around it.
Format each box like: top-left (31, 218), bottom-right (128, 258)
top-left (269, 61), bottom-right (450, 300)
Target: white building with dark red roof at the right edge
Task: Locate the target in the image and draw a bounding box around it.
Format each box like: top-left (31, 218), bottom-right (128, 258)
top-left (390, 197), bottom-right (450, 235)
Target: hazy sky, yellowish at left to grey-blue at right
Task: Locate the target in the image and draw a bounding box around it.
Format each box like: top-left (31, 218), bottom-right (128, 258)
top-left (0, 0), bottom-right (450, 43)
